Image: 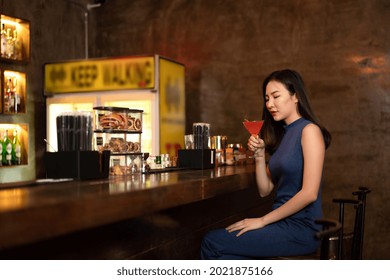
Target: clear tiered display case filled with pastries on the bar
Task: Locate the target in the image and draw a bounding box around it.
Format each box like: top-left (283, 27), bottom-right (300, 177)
top-left (93, 107), bottom-right (143, 175)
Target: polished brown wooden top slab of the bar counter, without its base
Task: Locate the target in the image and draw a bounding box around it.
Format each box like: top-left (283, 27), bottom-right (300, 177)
top-left (0, 165), bottom-right (255, 250)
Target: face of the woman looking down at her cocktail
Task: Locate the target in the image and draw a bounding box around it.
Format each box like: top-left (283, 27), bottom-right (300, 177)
top-left (265, 81), bottom-right (300, 124)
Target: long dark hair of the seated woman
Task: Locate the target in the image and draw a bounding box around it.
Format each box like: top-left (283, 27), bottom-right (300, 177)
top-left (261, 69), bottom-right (332, 154)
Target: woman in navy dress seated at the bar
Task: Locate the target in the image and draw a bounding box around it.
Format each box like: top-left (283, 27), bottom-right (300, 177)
top-left (201, 69), bottom-right (331, 259)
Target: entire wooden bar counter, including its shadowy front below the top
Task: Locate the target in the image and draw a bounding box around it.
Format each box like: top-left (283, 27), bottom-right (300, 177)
top-left (0, 165), bottom-right (272, 259)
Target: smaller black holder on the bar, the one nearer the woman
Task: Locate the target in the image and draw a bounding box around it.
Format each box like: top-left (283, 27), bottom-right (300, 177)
top-left (178, 149), bottom-right (215, 169)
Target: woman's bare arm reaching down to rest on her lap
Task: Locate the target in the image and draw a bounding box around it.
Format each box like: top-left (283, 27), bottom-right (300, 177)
top-left (227, 124), bottom-right (325, 236)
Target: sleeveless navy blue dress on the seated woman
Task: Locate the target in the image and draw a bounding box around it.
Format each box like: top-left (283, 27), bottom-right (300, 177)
top-left (201, 118), bottom-right (322, 259)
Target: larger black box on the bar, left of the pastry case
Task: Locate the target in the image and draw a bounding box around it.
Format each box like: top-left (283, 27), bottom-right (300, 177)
top-left (44, 151), bottom-right (110, 180)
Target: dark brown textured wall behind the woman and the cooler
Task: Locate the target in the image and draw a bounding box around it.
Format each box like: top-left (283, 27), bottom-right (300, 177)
top-left (0, 0), bottom-right (390, 259)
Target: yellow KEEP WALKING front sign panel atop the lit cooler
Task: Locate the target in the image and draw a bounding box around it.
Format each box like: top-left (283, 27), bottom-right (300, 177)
top-left (44, 56), bottom-right (155, 95)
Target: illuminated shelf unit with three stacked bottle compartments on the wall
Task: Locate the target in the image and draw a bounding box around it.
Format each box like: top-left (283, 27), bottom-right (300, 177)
top-left (0, 14), bottom-right (30, 182)
